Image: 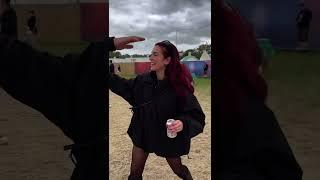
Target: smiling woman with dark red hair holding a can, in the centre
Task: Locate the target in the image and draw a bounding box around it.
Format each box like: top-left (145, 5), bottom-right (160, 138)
top-left (109, 41), bottom-right (205, 180)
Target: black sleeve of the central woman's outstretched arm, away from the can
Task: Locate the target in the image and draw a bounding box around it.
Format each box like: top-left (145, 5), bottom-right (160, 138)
top-left (108, 74), bottom-right (138, 105)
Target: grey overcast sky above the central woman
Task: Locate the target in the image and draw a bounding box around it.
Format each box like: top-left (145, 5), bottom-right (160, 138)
top-left (109, 0), bottom-right (211, 54)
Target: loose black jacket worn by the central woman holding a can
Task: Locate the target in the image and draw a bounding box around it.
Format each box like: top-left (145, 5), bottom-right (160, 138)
top-left (109, 72), bottom-right (205, 157)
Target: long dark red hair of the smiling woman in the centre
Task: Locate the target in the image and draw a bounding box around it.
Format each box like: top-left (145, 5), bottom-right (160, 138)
top-left (156, 41), bottom-right (194, 98)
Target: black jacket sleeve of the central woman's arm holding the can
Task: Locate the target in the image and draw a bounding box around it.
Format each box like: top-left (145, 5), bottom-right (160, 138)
top-left (175, 94), bottom-right (205, 138)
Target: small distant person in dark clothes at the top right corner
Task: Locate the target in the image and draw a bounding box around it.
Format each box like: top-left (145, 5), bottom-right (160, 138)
top-left (296, 3), bottom-right (312, 49)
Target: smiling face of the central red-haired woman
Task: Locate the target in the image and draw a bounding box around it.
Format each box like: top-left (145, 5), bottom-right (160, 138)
top-left (149, 45), bottom-right (170, 71)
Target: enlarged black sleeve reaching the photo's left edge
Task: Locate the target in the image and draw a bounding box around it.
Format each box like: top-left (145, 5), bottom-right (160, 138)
top-left (0, 37), bottom-right (77, 125)
